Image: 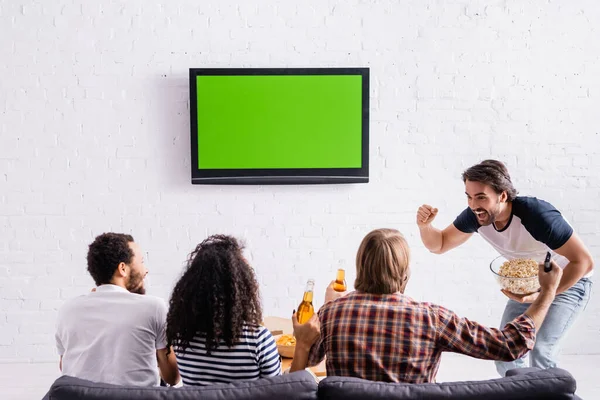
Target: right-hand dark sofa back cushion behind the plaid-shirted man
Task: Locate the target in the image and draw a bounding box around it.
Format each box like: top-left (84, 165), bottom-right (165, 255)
top-left (319, 368), bottom-right (576, 400)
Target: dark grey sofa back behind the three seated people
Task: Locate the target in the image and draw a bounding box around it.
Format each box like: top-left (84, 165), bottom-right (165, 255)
top-left (44, 368), bottom-right (579, 400)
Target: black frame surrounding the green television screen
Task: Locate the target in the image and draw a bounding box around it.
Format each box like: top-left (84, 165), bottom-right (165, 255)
top-left (190, 67), bottom-right (369, 185)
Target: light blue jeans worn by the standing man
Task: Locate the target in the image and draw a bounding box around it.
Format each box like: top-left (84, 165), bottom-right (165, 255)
top-left (496, 278), bottom-right (592, 376)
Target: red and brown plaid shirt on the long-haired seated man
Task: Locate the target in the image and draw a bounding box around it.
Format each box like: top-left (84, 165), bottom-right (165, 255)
top-left (308, 292), bottom-right (535, 383)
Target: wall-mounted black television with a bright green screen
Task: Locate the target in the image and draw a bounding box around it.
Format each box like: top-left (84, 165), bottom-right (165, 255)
top-left (190, 68), bottom-right (369, 184)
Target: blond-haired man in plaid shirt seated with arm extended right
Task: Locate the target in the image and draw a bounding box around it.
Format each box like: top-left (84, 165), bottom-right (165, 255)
top-left (304, 229), bottom-right (562, 383)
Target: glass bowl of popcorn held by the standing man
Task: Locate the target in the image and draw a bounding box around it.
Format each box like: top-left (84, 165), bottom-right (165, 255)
top-left (490, 256), bottom-right (540, 294)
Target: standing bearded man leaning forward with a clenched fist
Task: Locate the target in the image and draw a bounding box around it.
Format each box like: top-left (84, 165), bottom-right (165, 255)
top-left (417, 160), bottom-right (594, 376)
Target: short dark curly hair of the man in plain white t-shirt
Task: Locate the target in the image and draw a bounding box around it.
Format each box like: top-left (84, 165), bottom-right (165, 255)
top-left (87, 232), bottom-right (134, 286)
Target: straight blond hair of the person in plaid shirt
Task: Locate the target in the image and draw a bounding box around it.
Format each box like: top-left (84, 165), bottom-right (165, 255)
top-left (354, 229), bottom-right (410, 294)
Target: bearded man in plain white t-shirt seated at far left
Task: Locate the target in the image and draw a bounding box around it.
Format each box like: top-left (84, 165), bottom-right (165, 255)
top-left (56, 233), bottom-right (180, 386)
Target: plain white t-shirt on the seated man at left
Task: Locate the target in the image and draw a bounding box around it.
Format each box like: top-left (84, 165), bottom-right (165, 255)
top-left (56, 285), bottom-right (167, 386)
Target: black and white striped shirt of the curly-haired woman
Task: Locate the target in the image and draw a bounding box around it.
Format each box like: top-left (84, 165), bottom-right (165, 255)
top-left (175, 326), bottom-right (281, 386)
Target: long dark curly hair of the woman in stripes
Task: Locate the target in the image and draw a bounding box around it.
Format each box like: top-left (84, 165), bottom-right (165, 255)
top-left (167, 235), bottom-right (262, 354)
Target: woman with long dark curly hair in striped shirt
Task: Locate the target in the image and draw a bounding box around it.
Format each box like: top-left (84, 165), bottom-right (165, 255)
top-left (167, 235), bottom-right (281, 385)
